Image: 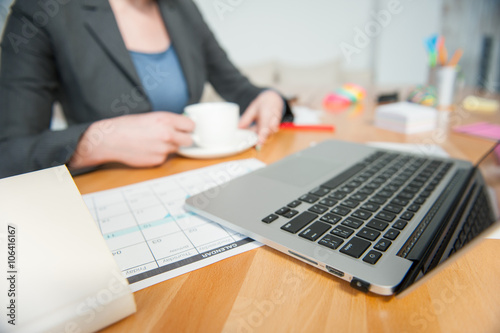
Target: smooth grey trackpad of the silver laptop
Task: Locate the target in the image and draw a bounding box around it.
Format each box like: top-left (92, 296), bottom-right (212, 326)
top-left (260, 157), bottom-right (344, 187)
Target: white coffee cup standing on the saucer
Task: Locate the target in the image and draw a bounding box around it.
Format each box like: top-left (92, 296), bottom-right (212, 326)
top-left (184, 102), bottom-right (240, 148)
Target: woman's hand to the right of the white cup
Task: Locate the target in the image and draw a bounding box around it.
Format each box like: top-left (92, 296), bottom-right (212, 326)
top-left (239, 90), bottom-right (284, 144)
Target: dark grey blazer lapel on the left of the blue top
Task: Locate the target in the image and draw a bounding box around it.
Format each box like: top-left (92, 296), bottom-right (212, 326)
top-left (82, 0), bottom-right (142, 89)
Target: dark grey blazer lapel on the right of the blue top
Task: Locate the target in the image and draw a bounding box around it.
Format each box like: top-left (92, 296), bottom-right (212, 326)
top-left (158, 1), bottom-right (203, 104)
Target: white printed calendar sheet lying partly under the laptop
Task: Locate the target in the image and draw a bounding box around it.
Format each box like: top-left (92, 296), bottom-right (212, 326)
top-left (83, 159), bottom-right (265, 291)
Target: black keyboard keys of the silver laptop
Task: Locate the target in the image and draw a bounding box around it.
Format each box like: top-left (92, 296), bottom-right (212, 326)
top-left (262, 151), bottom-right (452, 265)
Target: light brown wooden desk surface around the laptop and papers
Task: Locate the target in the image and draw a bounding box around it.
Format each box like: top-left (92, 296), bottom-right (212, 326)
top-left (75, 99), bottom-right (500, 333)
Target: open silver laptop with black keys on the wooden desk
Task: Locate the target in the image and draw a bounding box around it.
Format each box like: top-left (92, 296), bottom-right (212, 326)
top-left (186, 140), bottom-right (500, 295)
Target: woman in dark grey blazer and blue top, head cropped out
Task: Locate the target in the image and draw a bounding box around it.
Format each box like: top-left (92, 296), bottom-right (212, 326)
top-left (0, 0), bottom-right (290, 177)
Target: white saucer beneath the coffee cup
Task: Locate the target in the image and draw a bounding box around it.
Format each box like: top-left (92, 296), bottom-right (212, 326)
top-left (177, 129), bottom-right (257, 159)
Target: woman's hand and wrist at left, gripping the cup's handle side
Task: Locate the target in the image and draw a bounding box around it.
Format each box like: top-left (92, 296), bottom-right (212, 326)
top-left (68, 111), bottom-right (194, 169)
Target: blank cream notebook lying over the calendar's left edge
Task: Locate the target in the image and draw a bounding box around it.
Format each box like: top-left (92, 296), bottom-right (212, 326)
top-left (0, 166), bottom-right (136, 332)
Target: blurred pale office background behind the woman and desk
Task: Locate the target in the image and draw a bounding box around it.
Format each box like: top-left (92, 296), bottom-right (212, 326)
top-left (0, 0), bottom-right (500, 102)
